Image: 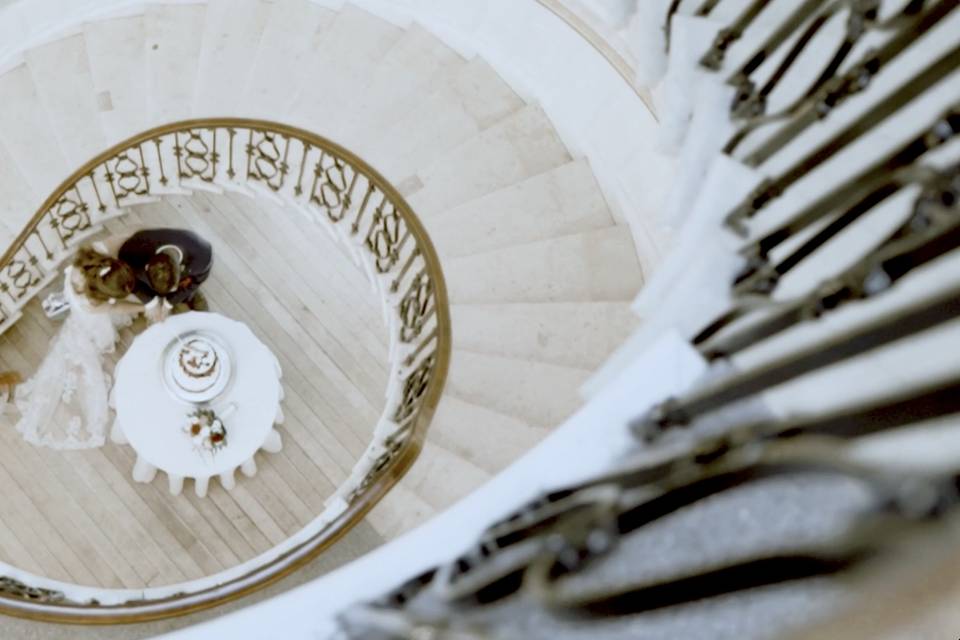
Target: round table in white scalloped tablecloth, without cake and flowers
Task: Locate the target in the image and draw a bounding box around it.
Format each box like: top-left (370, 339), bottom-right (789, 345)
top-left (111, 312), bottom-right (283, 497)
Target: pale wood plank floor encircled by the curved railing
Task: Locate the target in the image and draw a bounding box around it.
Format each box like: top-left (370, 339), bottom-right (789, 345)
top-left (0, 194), bottom-right (387, 589)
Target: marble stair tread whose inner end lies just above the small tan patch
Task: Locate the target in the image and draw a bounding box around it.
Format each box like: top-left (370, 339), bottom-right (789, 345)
top-left (355, 58), bottom-right (524, 182)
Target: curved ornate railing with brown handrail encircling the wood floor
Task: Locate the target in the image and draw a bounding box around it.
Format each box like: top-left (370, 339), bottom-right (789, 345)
top-left (0, 118), bottom-right (451, 624)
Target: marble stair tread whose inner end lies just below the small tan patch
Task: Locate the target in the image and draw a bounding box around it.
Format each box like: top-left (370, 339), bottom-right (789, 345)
top-left (408, 105), bottom-right (571, 216)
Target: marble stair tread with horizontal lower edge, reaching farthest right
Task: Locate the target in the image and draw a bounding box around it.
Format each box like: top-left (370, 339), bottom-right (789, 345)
top-left (443, 226), bottom-right (643, 304)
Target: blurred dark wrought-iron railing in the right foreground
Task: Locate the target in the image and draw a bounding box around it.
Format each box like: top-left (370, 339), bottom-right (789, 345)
top-left (332, 0), bottom-right (960, 640)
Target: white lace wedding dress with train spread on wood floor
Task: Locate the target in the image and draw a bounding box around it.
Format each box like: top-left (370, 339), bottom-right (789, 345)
top-left (15, 267), bottom-right (133, 449)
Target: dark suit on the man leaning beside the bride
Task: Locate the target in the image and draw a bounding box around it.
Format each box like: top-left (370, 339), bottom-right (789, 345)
top-left (118, 229), bottom-right (213, 304)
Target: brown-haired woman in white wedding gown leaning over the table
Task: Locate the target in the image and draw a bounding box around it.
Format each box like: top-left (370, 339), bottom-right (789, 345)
top-left (15, 245), bottom-right (144, 449)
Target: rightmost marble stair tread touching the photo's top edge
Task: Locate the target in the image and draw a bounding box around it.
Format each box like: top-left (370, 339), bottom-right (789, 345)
top-left (284, 4), bottom-right (404, 132)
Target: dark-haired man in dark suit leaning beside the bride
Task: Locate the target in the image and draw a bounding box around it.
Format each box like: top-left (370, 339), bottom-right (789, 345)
top-left (117, 229), bottom-right (213, 312)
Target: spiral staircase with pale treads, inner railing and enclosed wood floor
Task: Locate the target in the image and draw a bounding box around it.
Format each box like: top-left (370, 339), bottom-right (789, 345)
top-left (0, 0), bottom-right (644, 637)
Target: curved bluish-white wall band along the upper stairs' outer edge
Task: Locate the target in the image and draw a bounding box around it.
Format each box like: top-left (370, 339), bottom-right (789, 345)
top-left (0, 0), bottom-right (674, 271)
